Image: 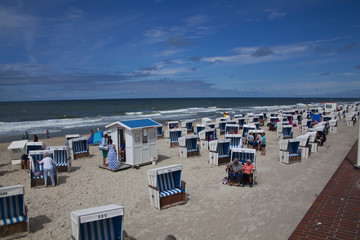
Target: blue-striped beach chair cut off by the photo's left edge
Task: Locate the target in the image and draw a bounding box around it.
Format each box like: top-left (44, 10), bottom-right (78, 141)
top-left (0, 185), bottom-right (29, 239)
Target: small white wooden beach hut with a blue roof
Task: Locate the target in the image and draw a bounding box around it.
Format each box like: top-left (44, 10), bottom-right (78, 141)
top-left (106, 118), bottom-right (161, 166)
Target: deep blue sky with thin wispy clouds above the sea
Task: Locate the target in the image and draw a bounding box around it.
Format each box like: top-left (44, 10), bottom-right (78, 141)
top-left (0, 0), bottom-right (360, 101)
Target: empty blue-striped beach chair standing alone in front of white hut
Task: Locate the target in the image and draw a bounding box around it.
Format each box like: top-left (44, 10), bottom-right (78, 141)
top-left (148, 164), bottom-right (187, 210)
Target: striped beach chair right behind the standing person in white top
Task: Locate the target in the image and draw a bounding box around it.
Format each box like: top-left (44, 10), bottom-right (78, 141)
top-left (29, 150), bottom-right (58, 188)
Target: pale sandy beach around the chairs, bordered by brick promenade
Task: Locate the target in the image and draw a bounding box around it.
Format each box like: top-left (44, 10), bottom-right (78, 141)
top-left (0, 119), bottom-right (358, 240)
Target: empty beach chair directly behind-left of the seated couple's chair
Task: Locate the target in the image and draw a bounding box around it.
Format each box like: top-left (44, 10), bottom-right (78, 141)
top-left (209, 139), bottom-right (231, 166)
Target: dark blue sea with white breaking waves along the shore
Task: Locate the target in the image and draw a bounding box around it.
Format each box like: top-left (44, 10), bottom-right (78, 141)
top-left (0, 98), bottom-right (359, 142)
